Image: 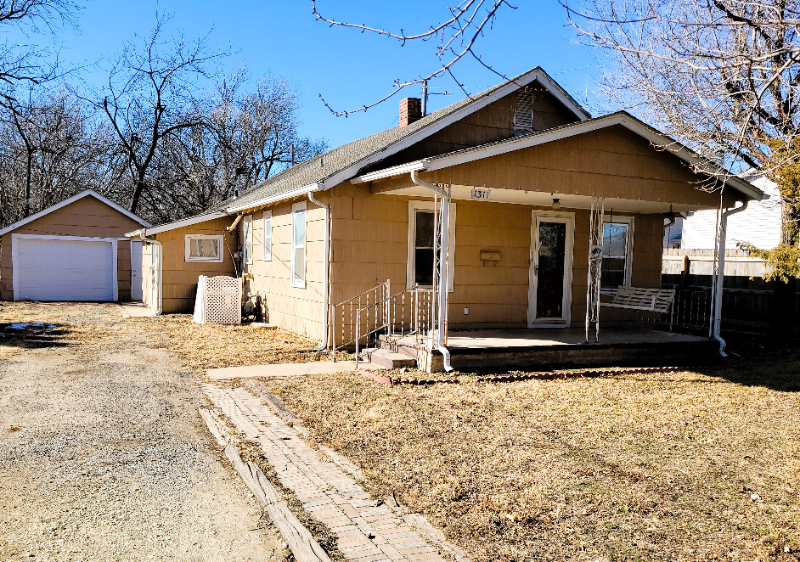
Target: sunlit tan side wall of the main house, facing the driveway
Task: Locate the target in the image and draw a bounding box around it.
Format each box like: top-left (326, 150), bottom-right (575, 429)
top-left (239, 194), bottom-right (327, 339)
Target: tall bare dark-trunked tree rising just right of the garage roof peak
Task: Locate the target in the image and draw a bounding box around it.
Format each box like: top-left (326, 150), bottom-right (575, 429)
top-left (98, 18), bottom-right (221, 213)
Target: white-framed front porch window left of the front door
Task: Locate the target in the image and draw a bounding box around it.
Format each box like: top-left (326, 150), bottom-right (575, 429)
top-left (406, 201), bottom-right (456, 291)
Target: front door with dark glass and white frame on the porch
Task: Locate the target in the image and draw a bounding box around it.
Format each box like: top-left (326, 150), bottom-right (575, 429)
top-left (528, 211), bottom-right (575, 328)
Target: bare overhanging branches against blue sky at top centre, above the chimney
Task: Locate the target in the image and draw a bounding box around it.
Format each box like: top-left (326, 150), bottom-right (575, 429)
top-left (311, 0), bottom-right (516, 116)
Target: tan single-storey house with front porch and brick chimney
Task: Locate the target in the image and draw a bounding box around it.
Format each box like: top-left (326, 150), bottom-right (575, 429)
top-left (125, 68), bottom-right (761, 368)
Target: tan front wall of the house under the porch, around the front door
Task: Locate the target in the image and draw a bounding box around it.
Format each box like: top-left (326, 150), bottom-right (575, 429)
top-left (322, 184), bottom-right (663, 330)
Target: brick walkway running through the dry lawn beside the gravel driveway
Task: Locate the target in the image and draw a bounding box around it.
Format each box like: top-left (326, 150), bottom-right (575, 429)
top-left (203, 385), bottom-right (444, 562)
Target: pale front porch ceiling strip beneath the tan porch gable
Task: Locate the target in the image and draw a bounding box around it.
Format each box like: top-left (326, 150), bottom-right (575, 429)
top-left (373, 185), bottom-right (710, 214)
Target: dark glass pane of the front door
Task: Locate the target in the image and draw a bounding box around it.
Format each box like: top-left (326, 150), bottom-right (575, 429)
top-left (536, 222), bottom-right (567, 318)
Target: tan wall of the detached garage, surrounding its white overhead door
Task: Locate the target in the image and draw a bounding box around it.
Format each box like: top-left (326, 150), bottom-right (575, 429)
top-left (0, 196), bottom-right (141, 301)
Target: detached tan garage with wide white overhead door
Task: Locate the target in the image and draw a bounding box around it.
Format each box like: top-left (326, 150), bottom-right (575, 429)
top-left (0, 190), bottom-right (149, 302)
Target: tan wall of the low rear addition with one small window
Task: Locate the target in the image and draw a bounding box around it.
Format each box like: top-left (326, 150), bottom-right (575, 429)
top-left (145, 217), bottom-right (238, 313)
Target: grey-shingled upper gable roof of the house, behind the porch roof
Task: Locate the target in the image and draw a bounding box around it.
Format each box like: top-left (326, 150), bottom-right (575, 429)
top-left (222, 67), bottom-right (591, 213)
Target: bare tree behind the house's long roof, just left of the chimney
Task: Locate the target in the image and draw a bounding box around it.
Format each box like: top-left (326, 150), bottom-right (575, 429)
top-left (148, 72), bottom-right (326, 220)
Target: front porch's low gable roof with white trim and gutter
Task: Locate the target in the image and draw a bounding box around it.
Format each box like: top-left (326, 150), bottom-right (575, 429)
top-left (351, 111), bottom-right (764, 200)
